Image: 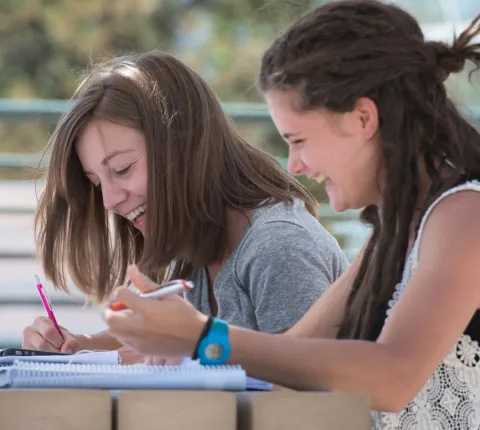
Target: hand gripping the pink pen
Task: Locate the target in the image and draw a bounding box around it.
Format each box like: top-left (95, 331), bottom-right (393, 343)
top-left (22, 317), bottom-right (80, 354)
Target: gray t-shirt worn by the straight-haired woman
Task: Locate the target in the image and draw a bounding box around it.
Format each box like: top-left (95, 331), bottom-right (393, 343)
top-left (185, 200), bottom-right (348, 333)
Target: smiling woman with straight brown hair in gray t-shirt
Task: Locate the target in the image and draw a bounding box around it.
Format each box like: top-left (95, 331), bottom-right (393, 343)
top-left (24, 52), bottom-right (347, 351)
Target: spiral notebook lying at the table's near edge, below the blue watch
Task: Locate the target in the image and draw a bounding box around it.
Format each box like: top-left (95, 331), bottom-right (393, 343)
top-left (0, 361), bottom-right (269, 391)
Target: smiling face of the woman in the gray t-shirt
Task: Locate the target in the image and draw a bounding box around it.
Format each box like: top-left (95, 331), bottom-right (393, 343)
top-left (75, 120), bottom-right (147, 234)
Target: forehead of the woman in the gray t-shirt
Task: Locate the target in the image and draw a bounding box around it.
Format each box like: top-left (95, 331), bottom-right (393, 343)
top-left (75, 120), bottom-right (145, 161)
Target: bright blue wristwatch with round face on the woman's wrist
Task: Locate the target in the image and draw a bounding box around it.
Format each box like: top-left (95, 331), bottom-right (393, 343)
top-left (194, 318), bottom-right (230, 365)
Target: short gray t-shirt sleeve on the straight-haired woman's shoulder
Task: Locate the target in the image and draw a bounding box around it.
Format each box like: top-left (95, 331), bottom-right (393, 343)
top-left (236, 221), bottom-right (347, 333)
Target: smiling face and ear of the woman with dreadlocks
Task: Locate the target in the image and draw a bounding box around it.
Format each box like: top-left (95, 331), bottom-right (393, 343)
top-left (265, 90), bottom-right (382, 212)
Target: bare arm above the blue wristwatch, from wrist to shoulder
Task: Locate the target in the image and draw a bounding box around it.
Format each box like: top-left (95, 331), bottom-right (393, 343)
top-left (226, 192), bottom-right (480, 411)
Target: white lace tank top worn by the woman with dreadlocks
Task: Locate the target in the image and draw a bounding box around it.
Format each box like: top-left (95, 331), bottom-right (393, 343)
top-left (372, 181), bottom-right (480, 430)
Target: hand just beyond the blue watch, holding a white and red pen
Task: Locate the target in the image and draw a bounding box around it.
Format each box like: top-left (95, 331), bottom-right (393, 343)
top-left (104, 266), bottom-right (207, 358)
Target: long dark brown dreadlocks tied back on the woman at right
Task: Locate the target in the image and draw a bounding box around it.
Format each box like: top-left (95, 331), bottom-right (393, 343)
top-left (259, 0), bottom-right (480, 339)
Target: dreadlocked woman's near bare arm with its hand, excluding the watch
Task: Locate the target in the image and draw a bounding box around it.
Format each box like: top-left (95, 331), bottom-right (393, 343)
top-left (105, 191), bottom-right (480, 411)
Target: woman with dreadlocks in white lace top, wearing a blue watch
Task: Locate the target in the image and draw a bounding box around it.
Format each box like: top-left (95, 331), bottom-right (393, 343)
top-left (105, 0), bottom-right (480, 430)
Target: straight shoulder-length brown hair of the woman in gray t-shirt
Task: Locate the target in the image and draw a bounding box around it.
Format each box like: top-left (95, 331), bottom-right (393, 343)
top-left (35, 51), bottom-right (317, 301)
